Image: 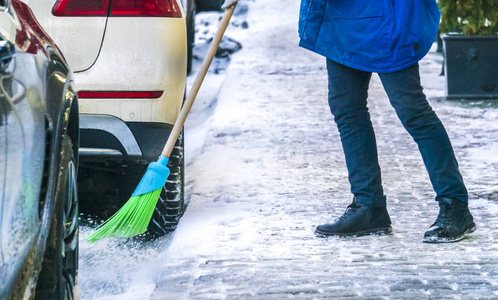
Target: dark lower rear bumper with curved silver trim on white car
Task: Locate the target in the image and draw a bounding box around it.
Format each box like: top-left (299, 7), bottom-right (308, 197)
top-left (79, 114), bottom-right (173, 164)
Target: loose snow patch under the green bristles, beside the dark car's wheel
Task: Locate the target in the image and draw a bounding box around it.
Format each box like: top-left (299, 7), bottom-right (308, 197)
top-left (79, 227), bottom-right (163, 300)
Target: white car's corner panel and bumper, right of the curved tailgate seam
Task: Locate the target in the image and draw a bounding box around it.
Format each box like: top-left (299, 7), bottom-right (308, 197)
top-left (78, 17), bottom-right (187, 124)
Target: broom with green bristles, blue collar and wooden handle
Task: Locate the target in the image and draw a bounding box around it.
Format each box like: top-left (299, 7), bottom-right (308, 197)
top-left (86, 1), bottom-right (237, 243)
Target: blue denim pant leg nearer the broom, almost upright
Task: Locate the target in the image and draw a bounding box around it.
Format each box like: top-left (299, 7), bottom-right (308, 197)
top-left (327, 59), bottom-right (386, 207)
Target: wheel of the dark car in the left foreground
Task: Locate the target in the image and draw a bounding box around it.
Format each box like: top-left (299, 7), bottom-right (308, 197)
top-left (35, 137), bottom-right (79, 300)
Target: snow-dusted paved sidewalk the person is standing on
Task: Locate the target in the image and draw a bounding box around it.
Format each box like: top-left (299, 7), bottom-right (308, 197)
top-left (151, 0), bottom-right (498, 299)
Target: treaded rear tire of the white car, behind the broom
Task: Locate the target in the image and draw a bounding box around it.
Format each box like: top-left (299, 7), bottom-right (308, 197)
top-left (147, 132), bottom-right (185, 237)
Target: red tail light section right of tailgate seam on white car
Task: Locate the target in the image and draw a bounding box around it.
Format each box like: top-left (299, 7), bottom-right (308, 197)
top-left (111, 0), bottom-right (182, 18)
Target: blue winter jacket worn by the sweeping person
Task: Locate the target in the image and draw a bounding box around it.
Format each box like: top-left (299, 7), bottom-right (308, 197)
top-left (299, 0), bottom-right (440, 73)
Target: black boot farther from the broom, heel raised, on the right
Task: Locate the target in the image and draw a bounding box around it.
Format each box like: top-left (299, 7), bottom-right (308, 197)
top-left (423, 198), bottom-right (476, 243)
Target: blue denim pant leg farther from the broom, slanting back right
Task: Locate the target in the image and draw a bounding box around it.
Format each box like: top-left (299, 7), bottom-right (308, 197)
top-left (379, 64), bottom-right (468, 203)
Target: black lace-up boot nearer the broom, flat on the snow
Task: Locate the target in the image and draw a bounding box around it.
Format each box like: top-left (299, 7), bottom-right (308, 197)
top-left (315, 198), bottom-right (392, 237)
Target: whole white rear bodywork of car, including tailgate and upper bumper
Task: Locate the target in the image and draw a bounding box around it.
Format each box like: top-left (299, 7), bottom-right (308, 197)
top-left (25, 0), bottom-right (187, 124)
